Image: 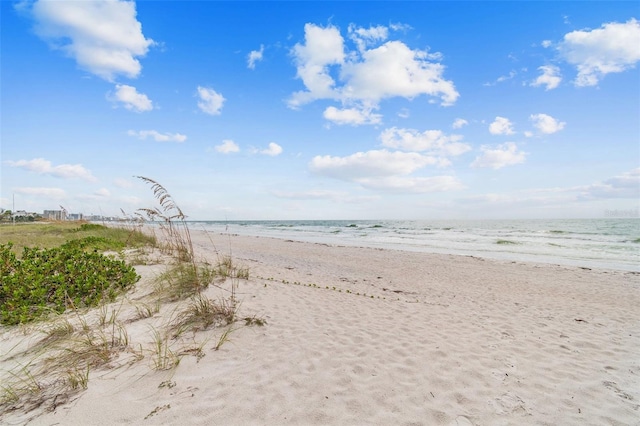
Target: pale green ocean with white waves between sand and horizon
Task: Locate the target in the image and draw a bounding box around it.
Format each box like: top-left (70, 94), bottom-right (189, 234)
top-left (195, 218), bottom-right (640, 272)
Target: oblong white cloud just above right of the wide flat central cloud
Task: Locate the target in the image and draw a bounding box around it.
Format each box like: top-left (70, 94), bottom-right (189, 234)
top-left (380, 127), bottom-right (471, 156)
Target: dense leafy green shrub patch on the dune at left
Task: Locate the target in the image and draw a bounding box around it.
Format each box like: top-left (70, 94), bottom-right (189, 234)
top-left (0, 243), bottom-right (140, 325)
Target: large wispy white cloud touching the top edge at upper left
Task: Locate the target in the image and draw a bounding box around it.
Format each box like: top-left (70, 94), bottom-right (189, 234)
top-left (23, 0), bottom-right (154, 81)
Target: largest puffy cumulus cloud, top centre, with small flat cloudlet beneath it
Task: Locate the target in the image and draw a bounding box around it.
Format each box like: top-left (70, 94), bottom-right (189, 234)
top-left (288, 24), bottom-right (459, 125)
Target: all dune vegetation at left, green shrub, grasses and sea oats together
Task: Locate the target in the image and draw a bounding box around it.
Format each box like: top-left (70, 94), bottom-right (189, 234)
top-left (0, 177), bottom-right (265, 422)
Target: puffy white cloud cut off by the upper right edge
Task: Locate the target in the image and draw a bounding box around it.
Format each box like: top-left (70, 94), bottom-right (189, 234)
top-left (558, 18), bottom-right (640, 87)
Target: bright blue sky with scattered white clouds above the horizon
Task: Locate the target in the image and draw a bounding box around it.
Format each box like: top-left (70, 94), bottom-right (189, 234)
top-left (0, 0), bottom-right (640, 221)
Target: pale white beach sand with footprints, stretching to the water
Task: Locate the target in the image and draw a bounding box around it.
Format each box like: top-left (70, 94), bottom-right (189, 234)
top-left (0, 232), bottom-right (640, 425)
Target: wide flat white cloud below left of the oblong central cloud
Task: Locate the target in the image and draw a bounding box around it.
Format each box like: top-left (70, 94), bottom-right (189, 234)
top-left (309, 150), bottom-right (438, 181)
